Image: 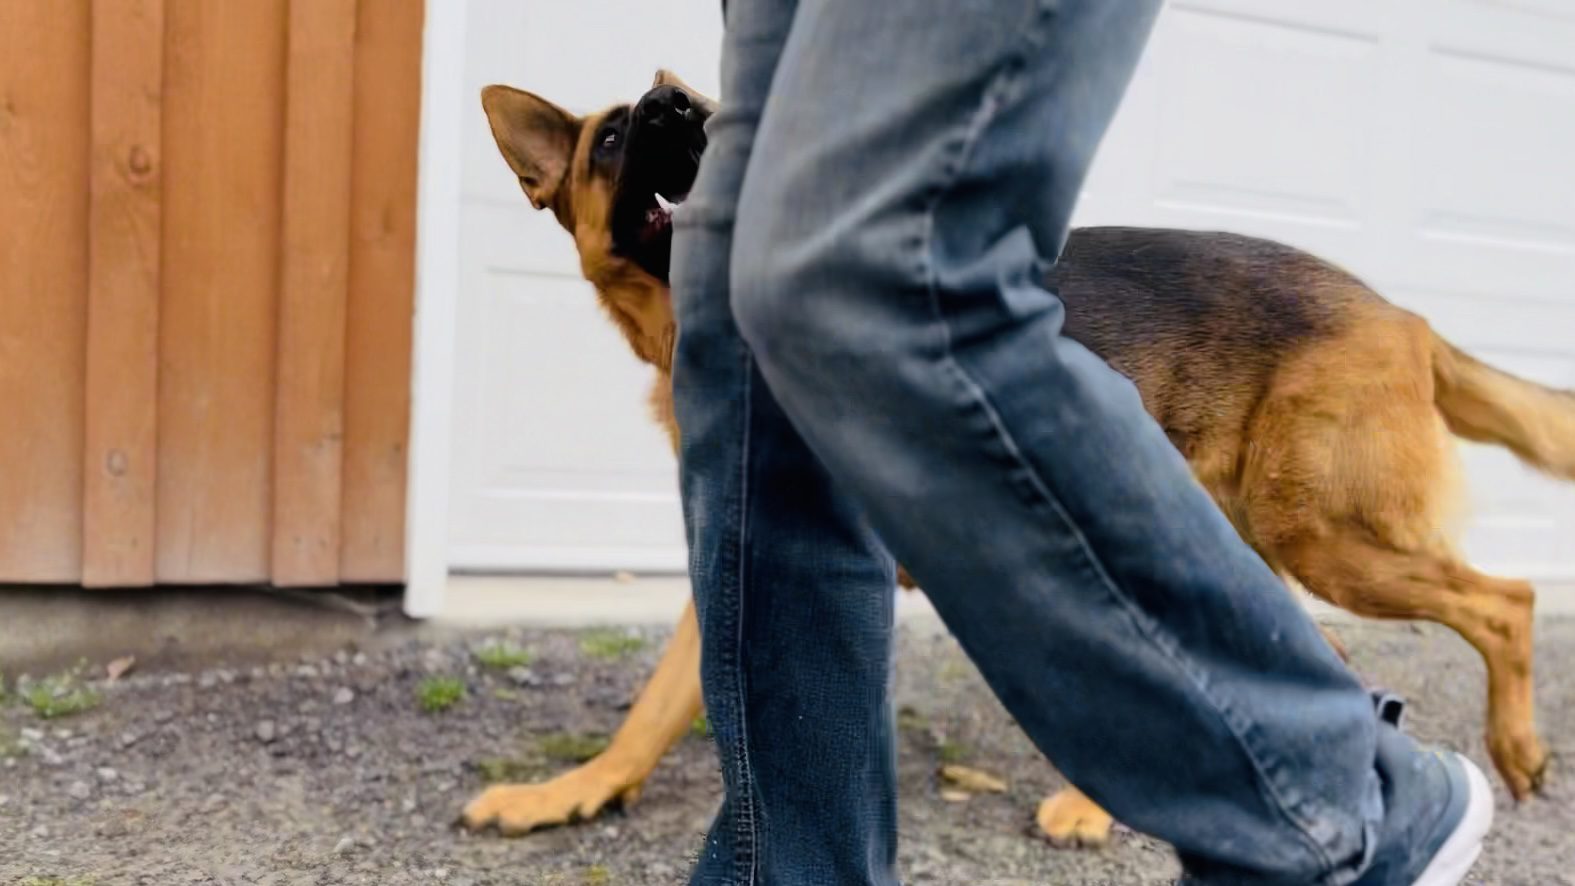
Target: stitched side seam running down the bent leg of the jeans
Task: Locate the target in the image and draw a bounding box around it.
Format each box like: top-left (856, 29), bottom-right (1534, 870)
top-left (918, 3), bottom-right (1334, 872)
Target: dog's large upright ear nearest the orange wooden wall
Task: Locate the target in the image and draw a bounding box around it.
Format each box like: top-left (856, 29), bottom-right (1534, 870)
top-left (482, 85), bottom-right (580, 209)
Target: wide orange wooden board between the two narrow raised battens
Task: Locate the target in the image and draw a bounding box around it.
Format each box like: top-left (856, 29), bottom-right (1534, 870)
top-left (156, 0), bottom-right (287, 582)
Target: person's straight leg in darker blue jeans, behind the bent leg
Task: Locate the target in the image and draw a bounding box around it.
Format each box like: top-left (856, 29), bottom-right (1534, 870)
top-left (671, 0), bottom-right (896, 886)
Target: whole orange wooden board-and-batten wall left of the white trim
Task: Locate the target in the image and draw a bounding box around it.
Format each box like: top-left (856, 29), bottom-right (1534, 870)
top-left (0, 0), bottom-right (422, 585)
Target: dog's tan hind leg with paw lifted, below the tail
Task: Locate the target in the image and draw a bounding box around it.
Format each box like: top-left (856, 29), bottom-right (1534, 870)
top-left (1280, 527), bottom-right (1548, 799)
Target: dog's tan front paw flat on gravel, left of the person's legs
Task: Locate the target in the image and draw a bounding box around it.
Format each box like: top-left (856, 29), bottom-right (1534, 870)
top-left (458, 766), bottom-right (639, 837)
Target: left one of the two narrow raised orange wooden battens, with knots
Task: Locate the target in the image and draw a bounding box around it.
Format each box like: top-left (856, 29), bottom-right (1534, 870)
top-left (82, 0), bottom-right (164, 585)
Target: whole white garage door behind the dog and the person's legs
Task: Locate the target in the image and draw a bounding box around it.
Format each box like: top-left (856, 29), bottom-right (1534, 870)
top-left (450, 0), bottom-right (1575, 579)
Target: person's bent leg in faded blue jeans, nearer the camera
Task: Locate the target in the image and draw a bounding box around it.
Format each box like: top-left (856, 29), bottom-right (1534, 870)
top-left (730, 0), bottom-right (1460, 883)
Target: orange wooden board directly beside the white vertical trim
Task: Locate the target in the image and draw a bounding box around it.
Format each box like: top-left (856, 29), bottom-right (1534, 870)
top-left (340, 0), bottom-right (424, 582)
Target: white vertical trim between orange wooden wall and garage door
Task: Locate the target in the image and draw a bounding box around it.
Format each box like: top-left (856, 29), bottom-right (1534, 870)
top-left (405, 2), bottom-right (468, 618)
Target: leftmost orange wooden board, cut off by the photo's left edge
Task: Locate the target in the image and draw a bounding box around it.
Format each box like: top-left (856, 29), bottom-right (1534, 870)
top-left (0, 0), bottom-right (91, 582)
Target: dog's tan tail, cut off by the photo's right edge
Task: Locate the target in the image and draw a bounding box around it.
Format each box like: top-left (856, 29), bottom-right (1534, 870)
top-left (1433, 334), bottom-right (1575, 480)
